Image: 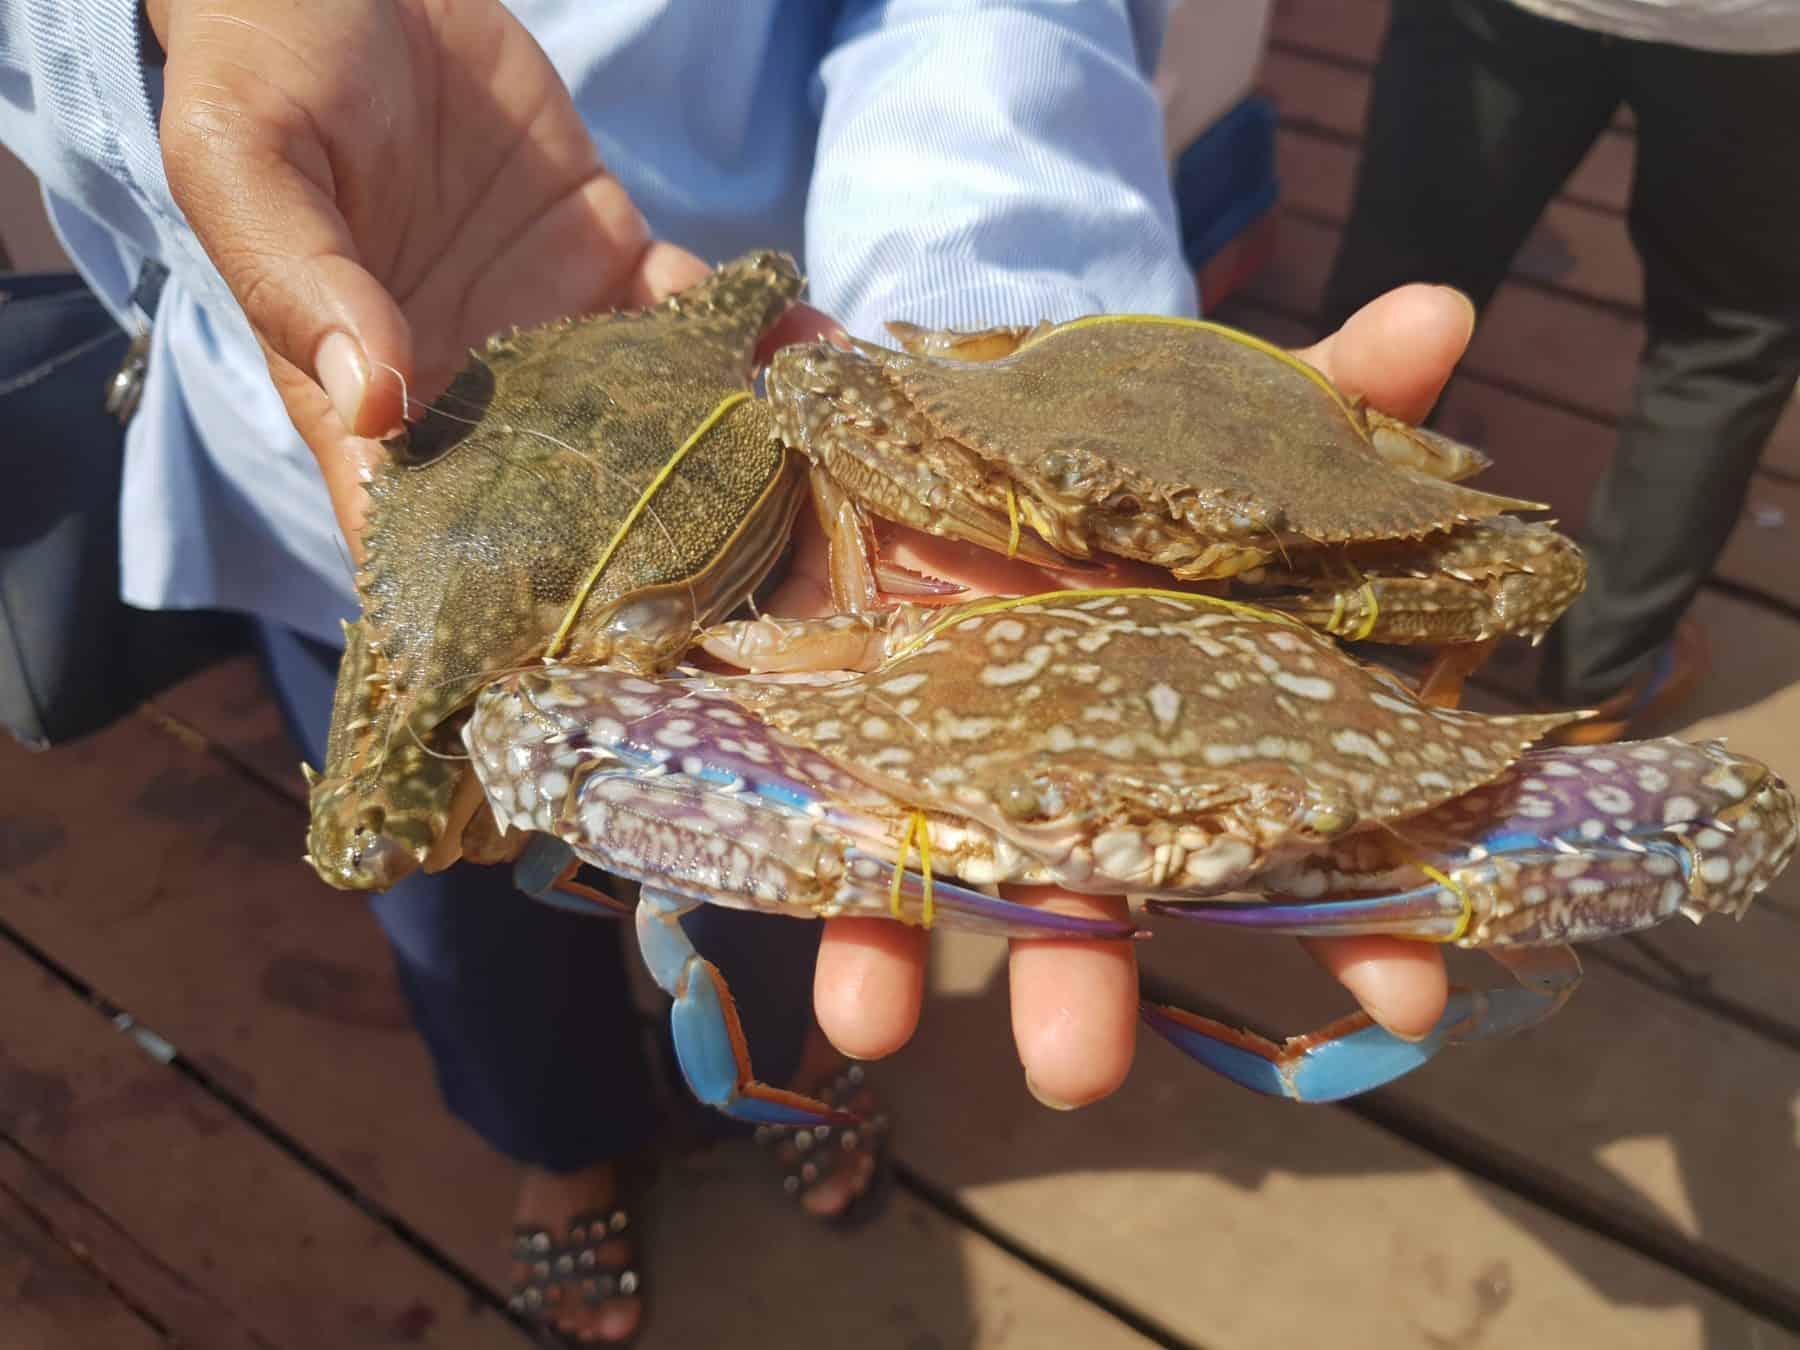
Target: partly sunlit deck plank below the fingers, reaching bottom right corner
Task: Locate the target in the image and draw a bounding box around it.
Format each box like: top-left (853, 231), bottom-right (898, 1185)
top-left (877, 934), bottom-right (1800, 1350)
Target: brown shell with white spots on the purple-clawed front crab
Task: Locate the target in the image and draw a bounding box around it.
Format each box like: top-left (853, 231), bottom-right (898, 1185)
top-left (716, 592), bottom-right (1579, 891)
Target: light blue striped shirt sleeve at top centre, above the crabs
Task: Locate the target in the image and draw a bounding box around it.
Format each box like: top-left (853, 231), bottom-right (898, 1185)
top-left (806, 0), bottom-right (1199, 340)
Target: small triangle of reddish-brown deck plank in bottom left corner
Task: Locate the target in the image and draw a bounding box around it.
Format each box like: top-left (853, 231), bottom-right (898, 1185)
top-left (0, 1186), bottom-right (167, 1350)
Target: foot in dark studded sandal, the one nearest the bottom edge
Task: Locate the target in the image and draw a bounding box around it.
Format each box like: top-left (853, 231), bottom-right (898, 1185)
top-left (513, 1163), bottom-right (644, 1345)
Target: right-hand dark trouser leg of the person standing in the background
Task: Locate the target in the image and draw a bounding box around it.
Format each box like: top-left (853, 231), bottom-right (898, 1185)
top-left (1544, 43), bottom-right (1800, 704)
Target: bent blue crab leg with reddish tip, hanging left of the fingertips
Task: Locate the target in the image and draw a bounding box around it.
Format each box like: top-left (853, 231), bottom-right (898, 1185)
top-left (637, 886), bottom-right (862, 1125)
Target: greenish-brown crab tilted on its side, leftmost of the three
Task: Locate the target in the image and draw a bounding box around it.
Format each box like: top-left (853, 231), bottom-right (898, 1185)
top-left (304, 254), bottom-right (806, 889)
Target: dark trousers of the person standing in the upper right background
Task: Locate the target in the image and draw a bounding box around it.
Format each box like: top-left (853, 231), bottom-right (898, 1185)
top-left (1325, 0), bottom-right (1800, 704)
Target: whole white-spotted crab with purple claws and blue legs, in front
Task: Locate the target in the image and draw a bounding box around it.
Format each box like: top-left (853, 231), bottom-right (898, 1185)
top-left (464, 590), bottom-right (1795, 1123)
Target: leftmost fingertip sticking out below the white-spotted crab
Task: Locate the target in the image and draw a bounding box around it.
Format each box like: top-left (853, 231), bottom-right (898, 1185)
top-left (812, 918), bottom-right (927, 1060)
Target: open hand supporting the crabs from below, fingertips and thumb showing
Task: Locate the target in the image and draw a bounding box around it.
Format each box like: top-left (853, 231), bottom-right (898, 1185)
top-left (795, 286), bottom-right (1474, 1107)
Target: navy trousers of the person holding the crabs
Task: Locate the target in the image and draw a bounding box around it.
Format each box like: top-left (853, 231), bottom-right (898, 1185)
top-left (259, 623), bottom-right (819, 1172)
